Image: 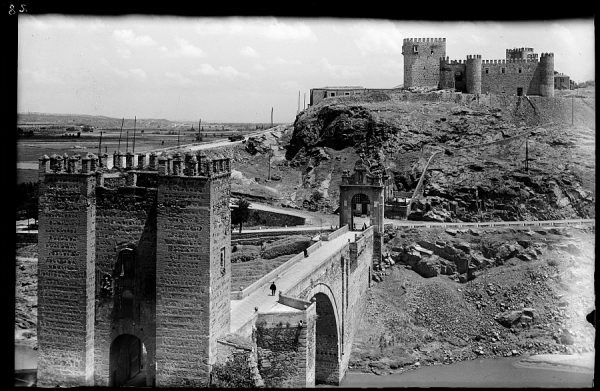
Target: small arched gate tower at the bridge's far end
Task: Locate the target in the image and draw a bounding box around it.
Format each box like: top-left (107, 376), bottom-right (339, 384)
top-left (340, 159), bottom-right (391, 266)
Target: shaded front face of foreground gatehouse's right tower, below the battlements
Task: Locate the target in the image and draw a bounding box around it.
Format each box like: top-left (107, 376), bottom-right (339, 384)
top-left (156, 175), bottom-right (211, 387)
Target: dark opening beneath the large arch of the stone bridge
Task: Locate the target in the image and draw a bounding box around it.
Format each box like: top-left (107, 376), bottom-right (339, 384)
top-left (314, 292), bottom-right (340, 385)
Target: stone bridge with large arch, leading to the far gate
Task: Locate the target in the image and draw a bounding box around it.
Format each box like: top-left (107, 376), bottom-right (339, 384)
top-left (225, 226), bottom-right (375, 387)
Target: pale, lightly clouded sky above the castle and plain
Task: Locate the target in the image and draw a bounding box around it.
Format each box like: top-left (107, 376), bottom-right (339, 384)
top-left (17, 15), bottom-right (595, 123)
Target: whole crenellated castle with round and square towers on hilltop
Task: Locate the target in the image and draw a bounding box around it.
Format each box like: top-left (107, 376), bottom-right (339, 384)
top-left (402, 38), bottom-right (554, 97)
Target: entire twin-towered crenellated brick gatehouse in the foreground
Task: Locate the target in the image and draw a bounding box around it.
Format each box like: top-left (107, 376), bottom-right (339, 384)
top-left (37, 152), bottom-right (231, 387)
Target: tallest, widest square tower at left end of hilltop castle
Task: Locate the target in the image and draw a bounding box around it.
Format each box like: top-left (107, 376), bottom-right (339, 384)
top-left (402, 38), bottom-right (446, 88)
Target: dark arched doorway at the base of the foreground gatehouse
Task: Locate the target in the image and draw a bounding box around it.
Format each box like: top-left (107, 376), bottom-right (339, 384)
top-left (109, 334), bottom-right (146, 387)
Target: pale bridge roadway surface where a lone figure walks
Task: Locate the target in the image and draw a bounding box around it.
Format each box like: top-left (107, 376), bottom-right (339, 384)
top-left (230, 231), bottom-right (360, 333)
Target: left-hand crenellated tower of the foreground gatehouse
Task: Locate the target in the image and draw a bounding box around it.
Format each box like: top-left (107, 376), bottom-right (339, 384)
top-left (37, 155), bottom-right (97, 387)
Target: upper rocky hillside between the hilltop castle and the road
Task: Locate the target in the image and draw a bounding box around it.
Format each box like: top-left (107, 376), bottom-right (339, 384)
top-left (285, 92), bottom-right (595, 221)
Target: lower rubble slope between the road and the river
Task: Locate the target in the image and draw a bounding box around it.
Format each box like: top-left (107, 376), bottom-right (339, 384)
top-left (350, 228), bottom-right (595, 374)
